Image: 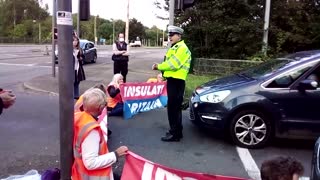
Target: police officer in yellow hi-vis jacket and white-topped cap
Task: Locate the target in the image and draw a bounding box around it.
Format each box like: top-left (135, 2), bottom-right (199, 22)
top-left (152, 26), bottom-right (191, 141)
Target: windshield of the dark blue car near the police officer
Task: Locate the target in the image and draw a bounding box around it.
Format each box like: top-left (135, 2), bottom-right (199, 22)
top-left (239, 58), bottom-right (299, 79)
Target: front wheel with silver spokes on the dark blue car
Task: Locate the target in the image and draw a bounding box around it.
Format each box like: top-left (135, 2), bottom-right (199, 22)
top-left (230, 110), bottom-right (271, 149)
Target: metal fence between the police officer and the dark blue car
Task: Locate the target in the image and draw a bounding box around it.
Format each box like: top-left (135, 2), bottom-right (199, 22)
top-left (193, 58), bottom-right (261, 75)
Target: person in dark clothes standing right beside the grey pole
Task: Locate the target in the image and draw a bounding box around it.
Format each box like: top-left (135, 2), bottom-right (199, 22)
top-left (73, 35), bottom-right (86, 100)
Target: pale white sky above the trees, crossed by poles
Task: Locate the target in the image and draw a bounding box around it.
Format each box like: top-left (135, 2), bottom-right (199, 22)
top-left (43, 0), bottom-right (169, 30)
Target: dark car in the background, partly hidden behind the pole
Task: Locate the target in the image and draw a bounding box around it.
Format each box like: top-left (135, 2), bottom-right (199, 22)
top-left (55, 39), bottom-right (98, 63)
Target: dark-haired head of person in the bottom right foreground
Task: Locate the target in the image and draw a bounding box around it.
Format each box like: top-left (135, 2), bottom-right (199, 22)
top-left (261, 157), bottom-right (303, 180)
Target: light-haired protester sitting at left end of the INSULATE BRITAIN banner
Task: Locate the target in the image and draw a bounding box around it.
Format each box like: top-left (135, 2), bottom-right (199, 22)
top-left (107, 74), bottom-right (123, 116)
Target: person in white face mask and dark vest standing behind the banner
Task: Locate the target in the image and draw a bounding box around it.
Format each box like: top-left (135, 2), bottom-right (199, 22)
top-left (112, 33), bottom-right (129, 82)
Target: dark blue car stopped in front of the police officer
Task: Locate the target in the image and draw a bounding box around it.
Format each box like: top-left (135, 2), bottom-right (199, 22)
top-left (189, 50), bottom-right (320, 148)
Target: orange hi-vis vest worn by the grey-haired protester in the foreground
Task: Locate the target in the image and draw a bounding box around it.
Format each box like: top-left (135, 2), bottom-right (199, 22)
top-left (72, 112), bottom-right (111, 180)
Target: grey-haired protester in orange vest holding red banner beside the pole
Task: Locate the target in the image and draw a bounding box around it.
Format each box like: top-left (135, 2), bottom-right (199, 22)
top-left (72, 88), bottom-right (128, 180)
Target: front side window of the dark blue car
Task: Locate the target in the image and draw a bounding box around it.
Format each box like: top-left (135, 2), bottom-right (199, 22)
top-left (267, 64), bottom-right (314, 88)
